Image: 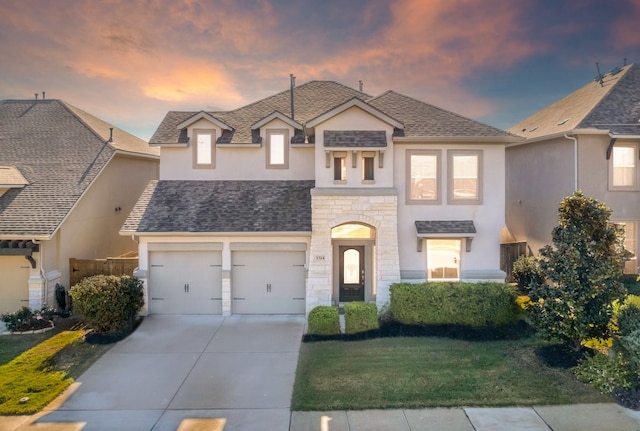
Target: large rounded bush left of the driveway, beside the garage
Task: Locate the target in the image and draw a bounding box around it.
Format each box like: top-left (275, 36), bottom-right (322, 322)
top-left (69, 275), bottom-right (144, 335)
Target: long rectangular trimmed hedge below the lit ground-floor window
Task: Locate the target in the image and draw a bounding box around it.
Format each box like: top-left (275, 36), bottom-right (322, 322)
top-left (391, 282), bottom-right (523, 327)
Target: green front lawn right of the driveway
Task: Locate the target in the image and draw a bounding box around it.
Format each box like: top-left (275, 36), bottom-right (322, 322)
top-left (292, 337), bottom-right (611, 410)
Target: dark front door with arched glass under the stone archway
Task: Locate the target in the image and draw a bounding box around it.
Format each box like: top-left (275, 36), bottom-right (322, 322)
top-left (338, 245), bottom-right (365, 302)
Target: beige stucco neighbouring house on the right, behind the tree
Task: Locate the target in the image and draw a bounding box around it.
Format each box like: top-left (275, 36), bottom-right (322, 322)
top-left (503, 64), bottom-right (640, 274)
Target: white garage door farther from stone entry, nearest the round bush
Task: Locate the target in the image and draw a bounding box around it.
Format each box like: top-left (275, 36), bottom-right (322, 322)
top-left (149, 251), bottom-right (222, 314)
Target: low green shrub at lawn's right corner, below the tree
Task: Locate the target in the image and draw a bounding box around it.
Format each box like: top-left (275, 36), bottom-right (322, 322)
top-left (572, 352), bottom-right (635, 394)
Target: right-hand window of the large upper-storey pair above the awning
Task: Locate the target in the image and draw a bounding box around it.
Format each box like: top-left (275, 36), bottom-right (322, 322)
top-left (447, 150), bottom-right (482, 204)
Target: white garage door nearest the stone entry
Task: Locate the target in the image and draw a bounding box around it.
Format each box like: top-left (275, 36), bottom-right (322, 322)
top-left (231, 250), bottom-right (305, 314)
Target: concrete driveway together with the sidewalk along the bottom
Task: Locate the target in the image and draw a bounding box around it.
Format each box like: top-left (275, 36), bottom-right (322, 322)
top-left (0, 316), bottom-right (640, 431)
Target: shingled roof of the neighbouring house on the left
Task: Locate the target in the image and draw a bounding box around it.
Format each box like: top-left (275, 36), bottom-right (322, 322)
top-left (0, 99), bottom-right (159, 239)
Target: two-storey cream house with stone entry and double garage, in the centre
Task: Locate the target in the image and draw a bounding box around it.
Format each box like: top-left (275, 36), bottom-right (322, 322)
top-left (121, 81), bottom-right (517, 315)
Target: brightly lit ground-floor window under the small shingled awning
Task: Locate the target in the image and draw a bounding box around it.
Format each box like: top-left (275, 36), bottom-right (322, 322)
top-left (427, 239), bottom-right (462, 281)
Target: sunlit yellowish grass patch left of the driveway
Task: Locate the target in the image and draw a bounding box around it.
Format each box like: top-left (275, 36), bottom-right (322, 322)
top-left (0, 321), bottom-right (111, 415)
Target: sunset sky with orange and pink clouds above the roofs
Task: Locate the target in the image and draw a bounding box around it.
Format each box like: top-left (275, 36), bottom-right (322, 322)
top-left (0, 0), bottom-right (640, 140)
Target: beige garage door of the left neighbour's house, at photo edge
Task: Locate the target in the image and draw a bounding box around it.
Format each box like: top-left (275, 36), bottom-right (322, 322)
top-left (0, 256), bottom-right (31, 314)
